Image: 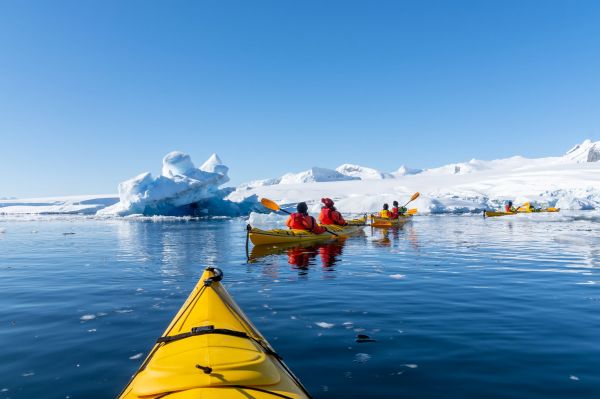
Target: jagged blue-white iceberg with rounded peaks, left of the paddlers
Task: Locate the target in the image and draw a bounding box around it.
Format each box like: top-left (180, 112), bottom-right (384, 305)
top-left (98, 151), bottom-right (244, 216)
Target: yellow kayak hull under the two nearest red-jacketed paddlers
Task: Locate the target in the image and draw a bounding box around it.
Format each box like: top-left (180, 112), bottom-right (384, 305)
top-left (248, 218), bottom-right (366, 245)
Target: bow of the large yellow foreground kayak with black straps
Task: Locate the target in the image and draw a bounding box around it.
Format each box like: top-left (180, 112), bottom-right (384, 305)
top-left (119, 267), bottom-right (310, 399)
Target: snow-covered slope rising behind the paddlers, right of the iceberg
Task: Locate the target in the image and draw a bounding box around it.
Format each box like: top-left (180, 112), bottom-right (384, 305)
top-left (228, 140), bottom-right (600, 214)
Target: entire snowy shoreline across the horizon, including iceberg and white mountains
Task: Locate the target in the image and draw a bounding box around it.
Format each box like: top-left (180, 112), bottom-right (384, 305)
top-left (0, 140), bottom-right (600, 217)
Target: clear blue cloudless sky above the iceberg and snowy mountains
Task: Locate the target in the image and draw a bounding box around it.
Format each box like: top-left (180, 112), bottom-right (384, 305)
top-left (0, 0), bottom-right (600, 197)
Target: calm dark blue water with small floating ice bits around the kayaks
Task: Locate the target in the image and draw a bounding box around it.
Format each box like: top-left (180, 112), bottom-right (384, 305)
top-left (0, 215), bottom-right (600, 399)
